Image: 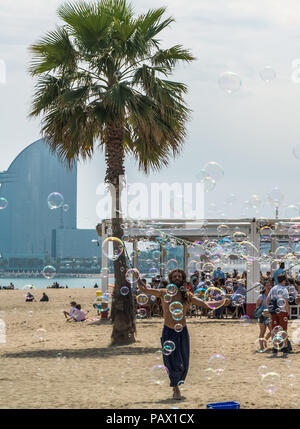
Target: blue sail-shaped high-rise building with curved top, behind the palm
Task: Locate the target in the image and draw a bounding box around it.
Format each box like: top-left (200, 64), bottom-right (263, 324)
top-left (0, 139), bottom-right (100, 271)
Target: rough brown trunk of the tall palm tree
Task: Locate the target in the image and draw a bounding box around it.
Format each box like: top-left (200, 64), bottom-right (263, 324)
top-left (105, 123), bottom-right (136, 345)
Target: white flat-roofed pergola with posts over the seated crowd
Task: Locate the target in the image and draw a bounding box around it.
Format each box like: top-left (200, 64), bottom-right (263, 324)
top-left (97, 218), bottom-right (300, 316)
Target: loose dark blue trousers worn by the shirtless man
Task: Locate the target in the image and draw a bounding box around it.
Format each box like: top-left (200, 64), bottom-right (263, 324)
top-left (160, 326), bottom-right (190, 387)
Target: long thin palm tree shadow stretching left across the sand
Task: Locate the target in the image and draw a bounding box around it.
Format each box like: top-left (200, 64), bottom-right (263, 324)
top-left (2, 346), bottom-right (161, 359)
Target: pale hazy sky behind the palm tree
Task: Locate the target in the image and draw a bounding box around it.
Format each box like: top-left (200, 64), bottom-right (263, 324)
top-left (0, 0), bottom-right (300, 228)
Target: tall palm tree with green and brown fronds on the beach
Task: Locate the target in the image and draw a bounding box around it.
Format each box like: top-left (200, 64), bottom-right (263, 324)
top-left (29, 0), bottom-right (194, 344)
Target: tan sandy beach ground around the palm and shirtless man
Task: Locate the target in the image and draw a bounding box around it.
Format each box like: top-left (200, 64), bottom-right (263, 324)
top-left (0, 289), bottom-right (300, 409)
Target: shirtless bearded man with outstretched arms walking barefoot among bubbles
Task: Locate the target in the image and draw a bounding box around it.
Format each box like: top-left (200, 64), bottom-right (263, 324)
top-left (138, 269), bottom-right (221, 400)
